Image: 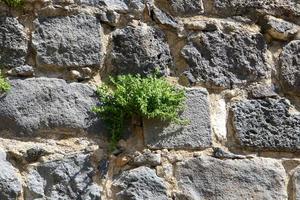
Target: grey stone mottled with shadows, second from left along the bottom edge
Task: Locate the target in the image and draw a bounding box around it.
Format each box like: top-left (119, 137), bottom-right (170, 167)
top-left (25, 154), bottom-right (101, 200)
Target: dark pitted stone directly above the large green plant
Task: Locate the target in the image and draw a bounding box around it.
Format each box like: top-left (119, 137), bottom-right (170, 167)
top-left (109, 24), bottom-right (173, 75)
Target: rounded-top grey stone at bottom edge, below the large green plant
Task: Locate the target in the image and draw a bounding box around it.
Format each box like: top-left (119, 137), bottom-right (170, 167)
top-left (112, 167), bottom-right (168, 200)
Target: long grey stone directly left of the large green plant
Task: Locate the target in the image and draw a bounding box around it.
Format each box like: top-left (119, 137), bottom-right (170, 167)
top-left (0, 78), bottom-right (100, 135)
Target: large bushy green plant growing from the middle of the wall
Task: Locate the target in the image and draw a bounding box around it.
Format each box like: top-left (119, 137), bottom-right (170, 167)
top-left (93, 75), bottom-right (186, 150)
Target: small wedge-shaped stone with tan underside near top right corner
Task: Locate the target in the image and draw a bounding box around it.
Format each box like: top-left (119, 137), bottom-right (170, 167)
top-left (264, 16), bottom-right (300, 41)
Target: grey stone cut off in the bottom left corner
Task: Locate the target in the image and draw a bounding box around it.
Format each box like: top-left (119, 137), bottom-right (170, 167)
top-left (0, 150), bottom-right (22, 200)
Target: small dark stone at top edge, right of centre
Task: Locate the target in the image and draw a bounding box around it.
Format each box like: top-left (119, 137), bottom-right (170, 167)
top-left (169, 0), bottom-right (204, 16)
